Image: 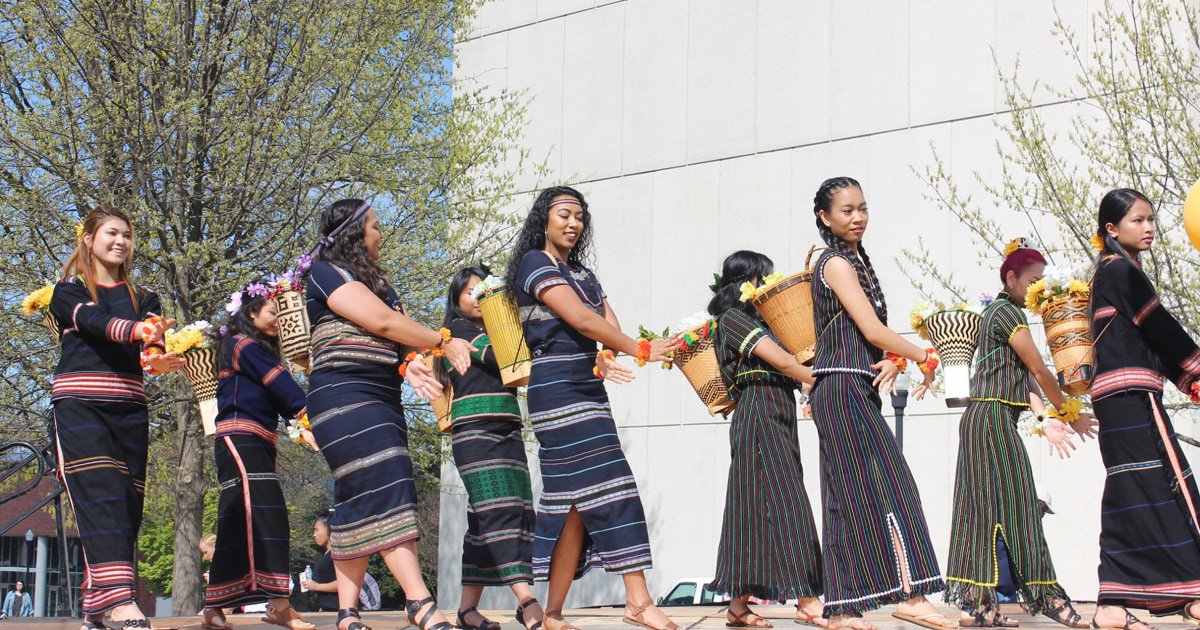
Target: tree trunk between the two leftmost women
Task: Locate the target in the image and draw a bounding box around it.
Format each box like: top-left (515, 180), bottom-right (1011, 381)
top-left (170, 378), bottom-right (209, 617)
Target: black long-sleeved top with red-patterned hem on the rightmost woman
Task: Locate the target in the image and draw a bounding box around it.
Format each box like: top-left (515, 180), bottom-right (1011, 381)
top-left (1092, 256), bottom-right (1200, 401)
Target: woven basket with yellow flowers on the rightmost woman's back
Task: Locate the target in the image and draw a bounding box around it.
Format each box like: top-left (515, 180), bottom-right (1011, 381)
top-left (1042, 295), bottom-right (1094, 396)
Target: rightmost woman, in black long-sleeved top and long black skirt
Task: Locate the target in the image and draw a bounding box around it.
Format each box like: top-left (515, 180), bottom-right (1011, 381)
top-left (1092, 188), bottom-right (1200, 630)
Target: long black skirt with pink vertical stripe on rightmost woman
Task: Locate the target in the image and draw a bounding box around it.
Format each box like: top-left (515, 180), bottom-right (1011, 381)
top-left (1092, 391), bottom-right (1200, 614)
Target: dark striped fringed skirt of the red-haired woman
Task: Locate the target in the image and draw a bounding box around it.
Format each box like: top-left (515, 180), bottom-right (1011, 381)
top-left (946, 401), bottom-right (1068, 614)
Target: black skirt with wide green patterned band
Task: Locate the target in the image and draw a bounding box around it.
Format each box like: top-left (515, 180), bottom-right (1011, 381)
top-left (451, 419), bottom-right (534, 587)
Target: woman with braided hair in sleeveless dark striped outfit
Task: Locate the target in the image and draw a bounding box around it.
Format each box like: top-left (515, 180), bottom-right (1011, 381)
top-left (811, 178), bottom-right (958, 630)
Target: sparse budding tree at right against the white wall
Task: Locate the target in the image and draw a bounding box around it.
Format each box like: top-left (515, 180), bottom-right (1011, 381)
top-left (901, 0), bottom-right (1200, 336)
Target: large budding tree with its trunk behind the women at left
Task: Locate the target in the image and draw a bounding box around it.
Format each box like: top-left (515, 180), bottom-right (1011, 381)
top-left (0, 0), bottom-right (524, 611)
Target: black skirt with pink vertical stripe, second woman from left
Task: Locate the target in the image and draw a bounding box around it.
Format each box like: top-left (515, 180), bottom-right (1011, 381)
top-left (204, 422), bottom-right (292, 608)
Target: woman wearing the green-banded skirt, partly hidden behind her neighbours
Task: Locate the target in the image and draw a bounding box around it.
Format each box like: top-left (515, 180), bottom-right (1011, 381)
top-left (434, 266), bottom-right (542, 630)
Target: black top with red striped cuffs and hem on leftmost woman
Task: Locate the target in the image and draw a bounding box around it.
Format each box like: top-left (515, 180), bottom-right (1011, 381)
top-left (50, 277), bottom-right (163, 402)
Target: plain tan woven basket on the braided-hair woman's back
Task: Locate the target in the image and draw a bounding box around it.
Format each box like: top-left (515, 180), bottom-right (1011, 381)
top-left (751, 247), bottom-right (817, 365)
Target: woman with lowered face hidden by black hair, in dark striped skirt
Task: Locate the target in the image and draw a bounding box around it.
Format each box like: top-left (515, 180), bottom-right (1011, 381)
top-left (708, 251), bottom-right (827, 628)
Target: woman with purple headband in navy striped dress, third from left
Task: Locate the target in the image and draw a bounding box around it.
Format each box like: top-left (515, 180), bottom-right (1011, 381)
top-left (307, 199), bottom-right (470, 630)
